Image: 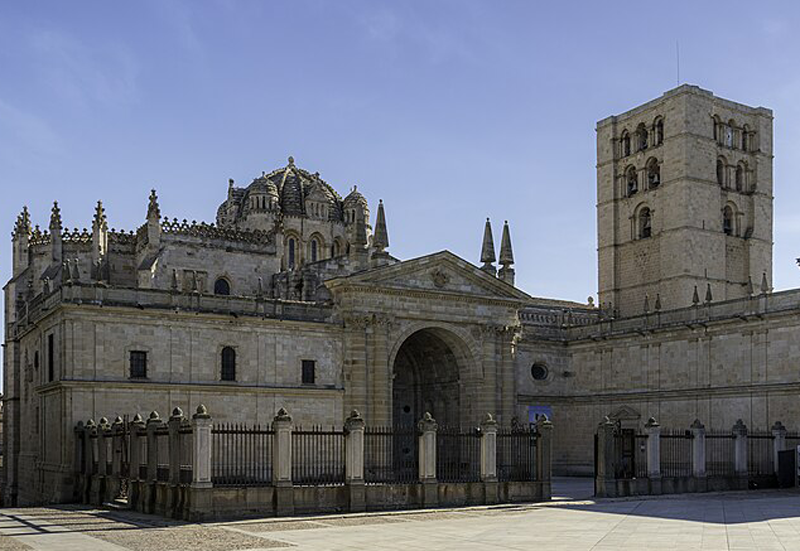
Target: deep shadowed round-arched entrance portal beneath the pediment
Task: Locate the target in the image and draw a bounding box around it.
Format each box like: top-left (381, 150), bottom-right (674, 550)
top-left (392, 328), bottom-right (466, 426)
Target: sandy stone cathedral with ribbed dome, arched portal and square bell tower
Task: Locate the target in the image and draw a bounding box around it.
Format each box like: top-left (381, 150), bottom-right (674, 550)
top-left (2, 85), bottom-right (800, 504)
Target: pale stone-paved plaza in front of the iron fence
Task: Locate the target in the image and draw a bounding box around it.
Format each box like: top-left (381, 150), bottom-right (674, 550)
top-left (0, 491), bottom-right (800, 551)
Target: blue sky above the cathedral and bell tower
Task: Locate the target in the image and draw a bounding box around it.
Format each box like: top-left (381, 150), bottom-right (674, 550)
top-left (0, 0), bottom-right (800, 306)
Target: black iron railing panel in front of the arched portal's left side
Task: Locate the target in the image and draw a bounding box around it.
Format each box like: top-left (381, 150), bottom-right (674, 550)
top-left (364, 426), bottom-right (419, 484)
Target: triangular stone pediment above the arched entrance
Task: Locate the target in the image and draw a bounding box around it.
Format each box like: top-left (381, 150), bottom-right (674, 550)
top-left (326, 251), bottom-right (531, 302)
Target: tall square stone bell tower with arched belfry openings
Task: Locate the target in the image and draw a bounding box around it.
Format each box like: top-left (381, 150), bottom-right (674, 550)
top-left (597, 85), bottom-right (773, 317)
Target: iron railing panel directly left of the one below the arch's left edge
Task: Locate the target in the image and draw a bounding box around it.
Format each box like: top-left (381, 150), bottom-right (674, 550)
top-left (292, 426), bottom-right (345, 486)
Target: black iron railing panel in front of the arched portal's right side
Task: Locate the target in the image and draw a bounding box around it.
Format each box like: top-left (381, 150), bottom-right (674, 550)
top-left (436, 427), bottom-right (481, 482)
